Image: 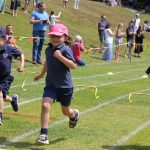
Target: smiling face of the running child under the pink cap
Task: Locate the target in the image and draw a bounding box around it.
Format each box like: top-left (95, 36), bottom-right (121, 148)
top-left (50, 35), bottom-right (65, 47)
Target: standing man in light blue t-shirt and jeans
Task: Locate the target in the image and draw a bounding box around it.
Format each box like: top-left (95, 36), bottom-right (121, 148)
top-left (30, 2), bottom-right (50, 64)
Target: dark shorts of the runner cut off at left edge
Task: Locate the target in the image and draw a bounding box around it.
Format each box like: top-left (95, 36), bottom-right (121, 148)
top-left (0, 75), bottom-right (14, 98)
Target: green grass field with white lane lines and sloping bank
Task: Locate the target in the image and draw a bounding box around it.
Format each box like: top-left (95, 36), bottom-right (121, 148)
top-left (0, 0), bottom-right (150, 150)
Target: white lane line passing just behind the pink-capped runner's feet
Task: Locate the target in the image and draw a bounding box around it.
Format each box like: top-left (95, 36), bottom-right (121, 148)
top-left (0, 88), bottom-right (150, 147)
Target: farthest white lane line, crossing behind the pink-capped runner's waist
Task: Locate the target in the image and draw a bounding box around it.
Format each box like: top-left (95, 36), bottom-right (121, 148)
top-left (11, 68), bottom-right (143, 89)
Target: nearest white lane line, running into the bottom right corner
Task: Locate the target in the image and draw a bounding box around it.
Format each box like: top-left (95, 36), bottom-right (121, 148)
top-left (108, 120), bottom-right (150, 150)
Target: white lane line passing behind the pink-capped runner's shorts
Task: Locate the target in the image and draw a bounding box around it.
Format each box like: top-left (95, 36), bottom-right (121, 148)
top-left (4, 77), bottom-right (142, 109)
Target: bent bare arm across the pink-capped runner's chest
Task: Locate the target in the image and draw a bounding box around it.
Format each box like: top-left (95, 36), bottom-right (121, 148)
top-left (54, 50), bottom-right (76, 69)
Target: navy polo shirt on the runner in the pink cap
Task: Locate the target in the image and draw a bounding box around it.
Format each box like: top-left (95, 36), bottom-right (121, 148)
top-left (45, 43), bottom-right (75, 88)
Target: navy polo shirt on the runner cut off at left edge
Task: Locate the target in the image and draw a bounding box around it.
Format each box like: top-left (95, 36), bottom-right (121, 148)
top-left (0, 44), bottom-right (21, 79)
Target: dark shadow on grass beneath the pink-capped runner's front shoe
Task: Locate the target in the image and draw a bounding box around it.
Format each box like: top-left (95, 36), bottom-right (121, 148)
top-left (0, 137), bottom-right (65, 150)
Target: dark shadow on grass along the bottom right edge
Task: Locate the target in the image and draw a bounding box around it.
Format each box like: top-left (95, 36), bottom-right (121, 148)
top-left (103, 145), bottom-right (150, 150)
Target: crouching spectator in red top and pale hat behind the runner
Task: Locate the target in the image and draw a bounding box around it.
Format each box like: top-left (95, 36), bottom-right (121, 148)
top-left (71, 35), bottom-right (85, 66)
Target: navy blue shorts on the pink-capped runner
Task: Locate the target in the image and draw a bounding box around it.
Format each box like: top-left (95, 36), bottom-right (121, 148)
top-left (43, 86), bottom-right (73, 106)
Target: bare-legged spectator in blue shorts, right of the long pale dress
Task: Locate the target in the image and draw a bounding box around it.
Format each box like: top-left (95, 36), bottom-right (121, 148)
top-left (115, 23), bottom-right (124, 61)
